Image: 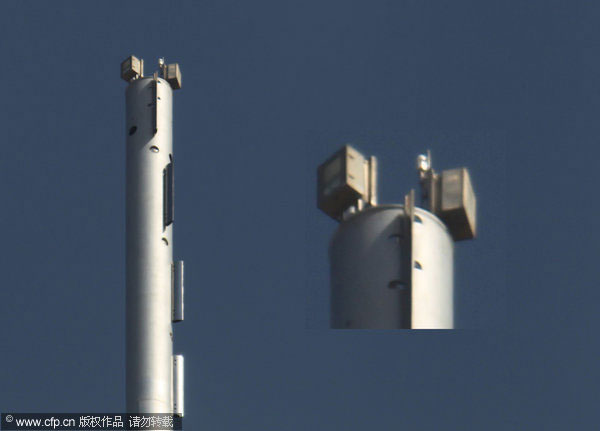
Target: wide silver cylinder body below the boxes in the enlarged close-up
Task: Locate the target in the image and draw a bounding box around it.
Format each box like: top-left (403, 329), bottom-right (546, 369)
top-left (329, 205), bottom-right (453, 329)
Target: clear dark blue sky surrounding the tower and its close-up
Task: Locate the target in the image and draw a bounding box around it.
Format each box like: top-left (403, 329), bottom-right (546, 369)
top-left (0, 1), bottom-right (600, 431)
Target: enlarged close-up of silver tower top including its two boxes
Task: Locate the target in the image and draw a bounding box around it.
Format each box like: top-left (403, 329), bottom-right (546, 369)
top-left (317, 145), bottom-right (476, 329)
